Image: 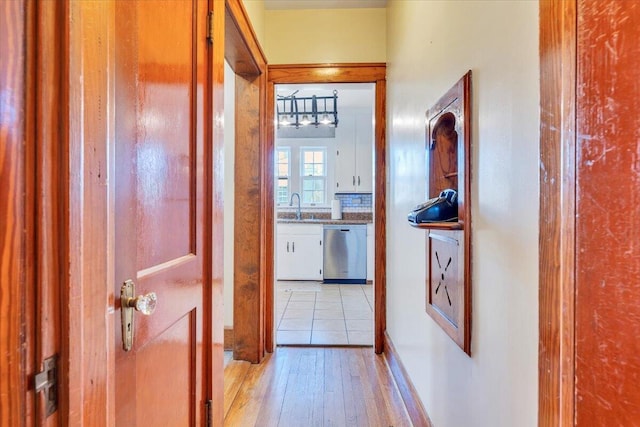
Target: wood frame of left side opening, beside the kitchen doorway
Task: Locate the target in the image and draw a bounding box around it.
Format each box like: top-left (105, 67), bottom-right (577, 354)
top-left (224, 0), bottom-right (273, 363)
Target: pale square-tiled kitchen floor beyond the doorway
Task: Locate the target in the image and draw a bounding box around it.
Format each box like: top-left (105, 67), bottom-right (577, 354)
top-left (276, 281), bottom-right (373, 345)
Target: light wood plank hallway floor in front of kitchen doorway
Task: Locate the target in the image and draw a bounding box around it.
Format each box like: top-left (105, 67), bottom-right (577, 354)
top-left (224, 347), bottom-right (411, 427)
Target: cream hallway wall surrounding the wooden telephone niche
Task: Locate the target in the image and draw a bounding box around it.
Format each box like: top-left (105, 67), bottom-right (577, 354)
top-left (387, 0), bottom-right (539, 427)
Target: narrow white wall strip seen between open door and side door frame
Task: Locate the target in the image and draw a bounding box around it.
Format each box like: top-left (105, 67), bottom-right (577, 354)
top-left (224, 61), bottom-right (236, 327)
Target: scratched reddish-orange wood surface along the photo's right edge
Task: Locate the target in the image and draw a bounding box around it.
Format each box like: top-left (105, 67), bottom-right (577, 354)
top-left (563, 0), bottom-right (640, 426)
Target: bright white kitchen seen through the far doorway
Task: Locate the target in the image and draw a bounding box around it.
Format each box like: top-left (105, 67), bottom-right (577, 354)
top-left (275, 84), bottom-right (375, 346)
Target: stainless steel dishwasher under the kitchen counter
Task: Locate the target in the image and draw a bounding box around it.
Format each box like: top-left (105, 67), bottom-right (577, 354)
top-left (323, 224), bottom-right (367, 283)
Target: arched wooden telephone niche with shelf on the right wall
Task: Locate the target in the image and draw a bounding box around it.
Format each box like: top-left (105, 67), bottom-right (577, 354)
top-left (422, 71), bottom-right (471, 355)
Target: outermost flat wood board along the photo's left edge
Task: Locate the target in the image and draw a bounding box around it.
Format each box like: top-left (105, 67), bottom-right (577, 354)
top-left (0, 0), bottom-right (37, 425)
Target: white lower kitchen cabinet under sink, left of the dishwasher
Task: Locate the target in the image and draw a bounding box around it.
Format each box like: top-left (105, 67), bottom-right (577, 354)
top-left (276, 224), bottom-right (323, 280)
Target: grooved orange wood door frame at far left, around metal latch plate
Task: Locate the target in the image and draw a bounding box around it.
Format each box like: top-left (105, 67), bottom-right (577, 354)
top-left (5, 0), bottom-right (69, 425)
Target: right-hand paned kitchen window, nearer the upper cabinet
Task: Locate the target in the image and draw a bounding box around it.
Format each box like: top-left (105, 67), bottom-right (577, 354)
top-left (300, 148), bottom-right (327, 205)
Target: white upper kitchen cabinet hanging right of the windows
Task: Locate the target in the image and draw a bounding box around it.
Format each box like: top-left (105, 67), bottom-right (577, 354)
top-left (335, 110), bottom-right (374, 193)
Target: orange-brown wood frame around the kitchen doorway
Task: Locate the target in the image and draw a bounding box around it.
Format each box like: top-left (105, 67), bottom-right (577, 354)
top-left (264, 63), bottom-right (387, 354)
